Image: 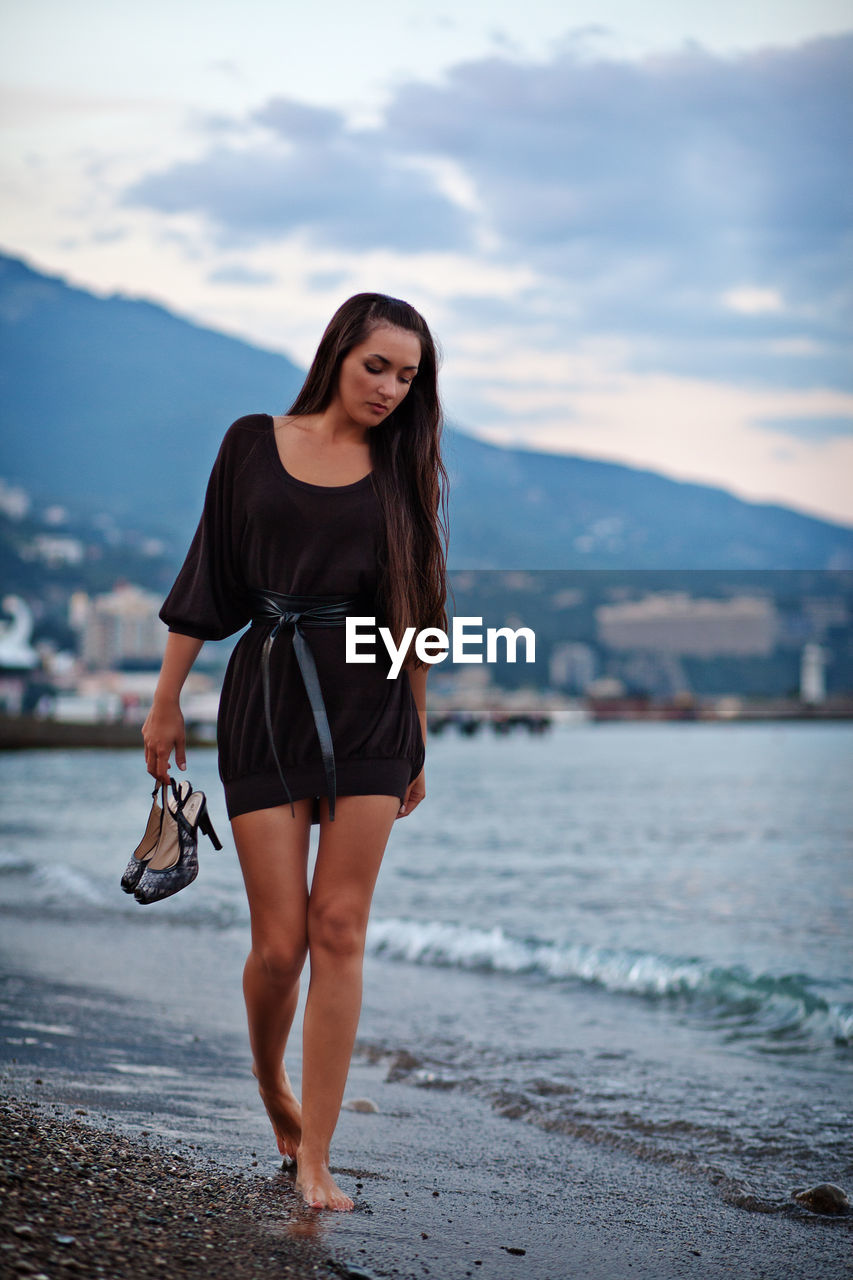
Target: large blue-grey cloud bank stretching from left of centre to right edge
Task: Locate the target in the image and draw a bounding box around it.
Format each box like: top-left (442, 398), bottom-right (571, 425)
top-left (124, 35), bottom-right (853, 417)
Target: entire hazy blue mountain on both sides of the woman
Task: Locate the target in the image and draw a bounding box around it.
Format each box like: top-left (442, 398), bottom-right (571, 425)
top-left (0, 247), bottom-right (853, 570)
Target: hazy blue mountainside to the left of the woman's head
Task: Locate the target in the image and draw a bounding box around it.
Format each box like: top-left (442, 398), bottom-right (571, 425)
top-left (0, 256), bottom-right (305, 527)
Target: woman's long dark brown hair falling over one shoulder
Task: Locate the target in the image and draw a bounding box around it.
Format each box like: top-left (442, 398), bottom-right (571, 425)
top-left (288, 293), bottom-right (448, 666)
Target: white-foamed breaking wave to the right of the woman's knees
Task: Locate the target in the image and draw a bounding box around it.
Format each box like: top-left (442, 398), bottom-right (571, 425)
top-left (368, 919), bottom-right (853, 1051)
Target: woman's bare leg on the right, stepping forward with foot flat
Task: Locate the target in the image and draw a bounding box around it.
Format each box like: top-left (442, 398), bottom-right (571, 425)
top-left (296, 796), bottom-right (400, 1210)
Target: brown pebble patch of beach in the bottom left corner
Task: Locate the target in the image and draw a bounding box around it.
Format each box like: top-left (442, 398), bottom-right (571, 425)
top-left (0, 1097), bottom-right (338, 1280)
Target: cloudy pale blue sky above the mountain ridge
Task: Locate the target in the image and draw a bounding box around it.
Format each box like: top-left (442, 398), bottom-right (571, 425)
top-left (0, 0), bottom-right (853, 525)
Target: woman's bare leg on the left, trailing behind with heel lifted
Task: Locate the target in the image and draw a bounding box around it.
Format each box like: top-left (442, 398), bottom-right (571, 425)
top-left (232, 800), bottom-right (311, 1158)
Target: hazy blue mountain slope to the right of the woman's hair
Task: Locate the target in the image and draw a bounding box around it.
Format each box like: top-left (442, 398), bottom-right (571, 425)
top-left (446, 431), bottom-right (853, 570)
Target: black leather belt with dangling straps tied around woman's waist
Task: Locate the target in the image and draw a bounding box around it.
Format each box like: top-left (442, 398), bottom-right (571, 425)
top-left (250, 591), bottom-right (371, 820)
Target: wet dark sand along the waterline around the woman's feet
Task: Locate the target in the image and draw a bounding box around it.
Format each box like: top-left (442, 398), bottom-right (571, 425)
top-left (0, 916), bottom-right (853, 1280)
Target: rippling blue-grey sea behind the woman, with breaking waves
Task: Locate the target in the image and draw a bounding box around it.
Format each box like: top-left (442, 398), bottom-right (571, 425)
top-left (0, 722), bottom-right (853, 1211)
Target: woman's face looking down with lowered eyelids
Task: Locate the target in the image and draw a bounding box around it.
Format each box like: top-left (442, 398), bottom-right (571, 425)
top-left (334, 325), bottom-right (420, 426)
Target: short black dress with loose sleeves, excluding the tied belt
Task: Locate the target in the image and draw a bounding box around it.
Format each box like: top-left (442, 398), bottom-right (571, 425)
top-left (160, 413), bottom-right (425, 822)
